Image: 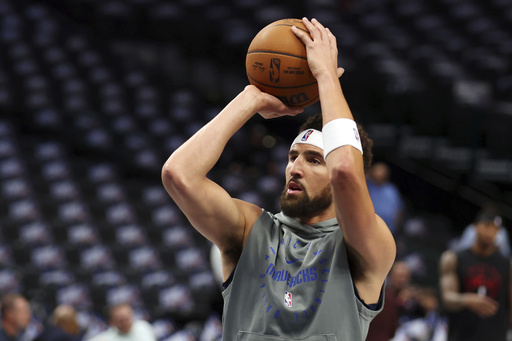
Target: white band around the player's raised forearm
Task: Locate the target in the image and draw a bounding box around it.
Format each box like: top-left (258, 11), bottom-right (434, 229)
top-left (322, 118), bottom-right (363, 159)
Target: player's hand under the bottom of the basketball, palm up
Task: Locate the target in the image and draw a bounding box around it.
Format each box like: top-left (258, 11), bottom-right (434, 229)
top-left (244, 85), bottom-right (304, 119)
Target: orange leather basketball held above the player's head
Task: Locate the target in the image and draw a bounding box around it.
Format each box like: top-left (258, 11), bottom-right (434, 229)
top-left (245, 19), bottom-right (318, 107)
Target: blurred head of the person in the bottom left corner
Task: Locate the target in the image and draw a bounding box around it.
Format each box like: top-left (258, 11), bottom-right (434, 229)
top-left (0, 294), bottom-right (32, 341)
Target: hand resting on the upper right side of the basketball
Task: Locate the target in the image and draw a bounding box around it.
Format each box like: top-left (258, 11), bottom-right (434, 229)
top-left (292, 18), bottom-right (344, 79)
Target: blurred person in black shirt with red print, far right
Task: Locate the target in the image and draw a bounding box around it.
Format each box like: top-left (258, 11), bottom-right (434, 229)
top-left (440, 206), bottom-right (512, 341)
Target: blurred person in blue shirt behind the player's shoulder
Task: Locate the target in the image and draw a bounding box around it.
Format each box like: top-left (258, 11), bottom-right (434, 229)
top-left (366, 162), bottom-right (404, 236)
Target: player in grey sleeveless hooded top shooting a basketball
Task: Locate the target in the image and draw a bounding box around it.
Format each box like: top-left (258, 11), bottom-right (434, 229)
top-left (162, 18), bottom-right (396, 341)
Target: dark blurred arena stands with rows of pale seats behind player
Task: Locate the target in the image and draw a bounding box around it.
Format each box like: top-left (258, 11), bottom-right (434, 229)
top-left (0, 0), bottom-right (512, 340)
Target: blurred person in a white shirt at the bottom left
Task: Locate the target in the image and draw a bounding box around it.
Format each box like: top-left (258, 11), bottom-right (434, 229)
top-left (90, 303), bottom-right (156, 341)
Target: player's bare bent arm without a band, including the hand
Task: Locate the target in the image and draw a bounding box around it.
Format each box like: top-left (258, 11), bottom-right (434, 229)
top-left (162, 85), bottom-right (302, 274)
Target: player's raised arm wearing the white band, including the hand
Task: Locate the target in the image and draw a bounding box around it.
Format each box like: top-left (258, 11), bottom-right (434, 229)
top-left (294, 19), bottom-right (396, 303)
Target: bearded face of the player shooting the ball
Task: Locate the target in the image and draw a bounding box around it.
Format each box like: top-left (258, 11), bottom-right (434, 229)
top-left (281, 144), bottom-right (332, 218)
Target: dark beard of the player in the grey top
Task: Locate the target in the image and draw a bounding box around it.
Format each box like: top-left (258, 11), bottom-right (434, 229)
top-left (280, 179), bottom-right (332, 219)
